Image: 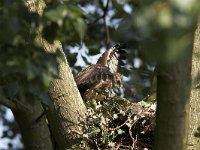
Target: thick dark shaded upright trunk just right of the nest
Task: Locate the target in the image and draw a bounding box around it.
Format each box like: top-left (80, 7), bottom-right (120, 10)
top-left (155, 54), bottom-right (192, 150)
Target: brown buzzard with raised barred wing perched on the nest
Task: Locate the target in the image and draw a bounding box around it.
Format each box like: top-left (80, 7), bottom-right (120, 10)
top-left (75, 44), bottom-right (126, 97)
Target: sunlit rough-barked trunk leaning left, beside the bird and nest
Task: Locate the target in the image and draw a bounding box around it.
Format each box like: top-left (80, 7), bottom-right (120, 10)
top-left (26, 0), bottom-right (86, 149)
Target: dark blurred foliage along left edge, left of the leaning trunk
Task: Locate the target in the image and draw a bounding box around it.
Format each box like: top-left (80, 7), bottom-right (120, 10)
top-left (0, 1), bottom-right (57, 100)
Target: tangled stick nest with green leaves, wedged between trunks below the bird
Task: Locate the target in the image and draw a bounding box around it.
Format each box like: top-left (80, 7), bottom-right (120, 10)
top-left (83, 96), bottom-right (155, 150)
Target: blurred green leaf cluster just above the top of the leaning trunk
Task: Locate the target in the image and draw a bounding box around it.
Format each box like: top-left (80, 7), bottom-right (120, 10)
top-left (41, 4), bottom-right (86, 43)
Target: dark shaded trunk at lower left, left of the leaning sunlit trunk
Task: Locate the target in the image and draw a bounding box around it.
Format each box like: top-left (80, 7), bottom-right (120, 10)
top-left (13, 101), bottom-right (54, 150)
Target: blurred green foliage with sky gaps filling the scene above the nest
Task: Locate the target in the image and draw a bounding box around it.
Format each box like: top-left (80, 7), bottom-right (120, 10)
top-left (0, 0), bottom-right (199, 148)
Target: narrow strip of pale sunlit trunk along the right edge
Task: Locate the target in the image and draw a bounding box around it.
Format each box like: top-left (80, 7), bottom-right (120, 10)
top-left (187, 18), bottom-right (200, 150)
